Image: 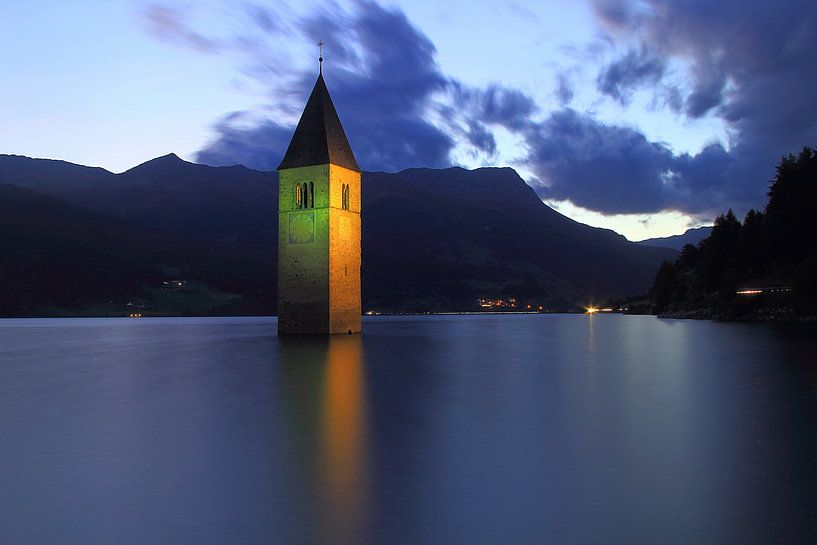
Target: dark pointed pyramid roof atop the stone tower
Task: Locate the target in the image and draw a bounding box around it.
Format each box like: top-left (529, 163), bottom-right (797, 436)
top-left (278, 66), bottom-right (360, 172)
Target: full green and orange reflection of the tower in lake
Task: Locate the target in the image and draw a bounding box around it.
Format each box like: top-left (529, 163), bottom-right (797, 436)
top-left (279, 335), bottom-right (368, 543)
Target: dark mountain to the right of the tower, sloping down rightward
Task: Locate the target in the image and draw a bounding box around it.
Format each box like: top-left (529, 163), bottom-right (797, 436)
top-left (363, 168), bottom-right (672, 308)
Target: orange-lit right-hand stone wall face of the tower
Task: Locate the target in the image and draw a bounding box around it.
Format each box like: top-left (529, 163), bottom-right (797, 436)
top-left (329, 165), bottom-right (362, 333)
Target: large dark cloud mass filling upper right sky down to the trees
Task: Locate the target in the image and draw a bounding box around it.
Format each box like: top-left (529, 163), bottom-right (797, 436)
top-left (526, 0), bottom-right (817, 215)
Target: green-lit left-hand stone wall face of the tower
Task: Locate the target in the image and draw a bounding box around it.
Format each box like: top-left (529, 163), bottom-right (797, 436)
top-left (278, 165), bottom-right (330, 334)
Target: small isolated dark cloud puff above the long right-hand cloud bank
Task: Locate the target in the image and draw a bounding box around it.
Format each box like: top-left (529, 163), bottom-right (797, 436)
top-left (597, 48), bottom-right (666, 104)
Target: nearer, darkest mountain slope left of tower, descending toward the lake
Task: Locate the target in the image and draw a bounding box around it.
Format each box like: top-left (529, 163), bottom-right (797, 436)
top-left (0, 184), bottom-right (274, 316)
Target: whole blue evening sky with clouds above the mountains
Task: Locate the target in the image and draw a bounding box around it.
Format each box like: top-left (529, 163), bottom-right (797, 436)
top-left (0, 0), bottom-right (817, 240)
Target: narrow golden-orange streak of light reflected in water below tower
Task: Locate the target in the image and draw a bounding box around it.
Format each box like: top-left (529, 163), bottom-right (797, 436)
top-left (319, 335), bottom-right (367, 543)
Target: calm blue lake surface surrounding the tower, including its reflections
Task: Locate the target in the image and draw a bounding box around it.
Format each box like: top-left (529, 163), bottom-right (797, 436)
top-left (0, 315), bottom-right (817, 545)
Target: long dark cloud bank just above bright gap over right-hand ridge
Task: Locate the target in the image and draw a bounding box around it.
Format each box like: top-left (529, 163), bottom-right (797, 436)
top-left (526, 109), bottom-right (773, 218)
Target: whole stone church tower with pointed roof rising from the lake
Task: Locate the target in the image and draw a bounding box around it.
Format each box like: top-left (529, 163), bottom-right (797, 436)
top-left (278, 57), bottom-right (361, 335)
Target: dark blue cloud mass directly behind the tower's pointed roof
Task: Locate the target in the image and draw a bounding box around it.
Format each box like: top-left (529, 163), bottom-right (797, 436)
top-left (198, 2), bottom-right (456, 171)
